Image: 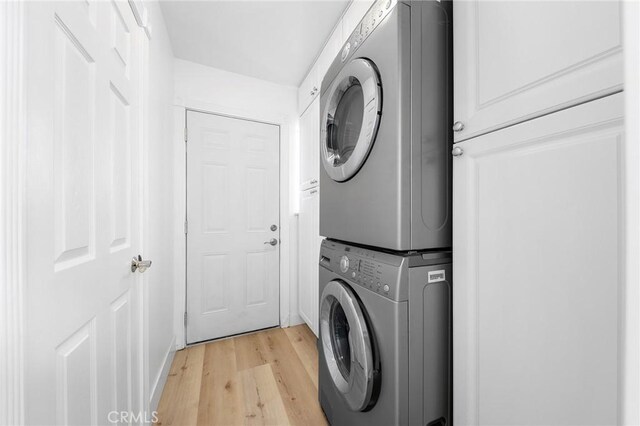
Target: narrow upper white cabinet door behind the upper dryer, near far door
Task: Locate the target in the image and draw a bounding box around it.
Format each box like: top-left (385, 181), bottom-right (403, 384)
top-left (300, 97), bottom-right (320, 190)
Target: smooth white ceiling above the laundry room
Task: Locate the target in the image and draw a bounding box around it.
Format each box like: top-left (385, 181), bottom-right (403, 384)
top-left (160, 0), bottom-right (349, 86)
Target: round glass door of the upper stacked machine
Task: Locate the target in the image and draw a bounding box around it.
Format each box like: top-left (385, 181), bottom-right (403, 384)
top-left (320, 58), bottom-right (382, 182)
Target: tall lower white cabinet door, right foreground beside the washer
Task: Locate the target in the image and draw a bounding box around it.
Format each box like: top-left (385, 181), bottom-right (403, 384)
top-left (453, 94), bottom-right (624, 426)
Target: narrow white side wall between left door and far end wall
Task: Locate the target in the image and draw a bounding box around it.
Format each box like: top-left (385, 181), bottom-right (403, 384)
top-left (142, 1), bottom-right (175, 410)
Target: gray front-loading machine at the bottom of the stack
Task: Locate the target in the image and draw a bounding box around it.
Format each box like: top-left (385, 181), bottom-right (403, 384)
top-left (318, 240), bottom-right (452, 426)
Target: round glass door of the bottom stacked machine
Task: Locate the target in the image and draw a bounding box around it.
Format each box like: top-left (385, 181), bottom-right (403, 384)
top-left (320, 281), bottom-right (379, 411)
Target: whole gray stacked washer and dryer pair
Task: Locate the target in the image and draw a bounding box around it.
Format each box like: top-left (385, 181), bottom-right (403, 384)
top-left (318, 0), bottom-right (452, 426)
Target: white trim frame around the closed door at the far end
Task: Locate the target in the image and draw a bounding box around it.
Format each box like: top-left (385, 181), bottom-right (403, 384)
top-left (174, 99), bottom-right (295, 350)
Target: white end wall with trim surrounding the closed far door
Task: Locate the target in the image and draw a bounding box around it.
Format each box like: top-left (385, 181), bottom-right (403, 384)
top-left (174, 59), bottom-right (302, 347)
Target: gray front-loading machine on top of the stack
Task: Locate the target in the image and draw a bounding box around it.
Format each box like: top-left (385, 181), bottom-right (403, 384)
top-left (319, 0), bottom-right (452, 251)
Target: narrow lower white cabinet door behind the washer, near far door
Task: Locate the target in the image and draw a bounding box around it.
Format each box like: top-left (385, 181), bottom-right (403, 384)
top-left (298, 188), bottom-right (322, 336)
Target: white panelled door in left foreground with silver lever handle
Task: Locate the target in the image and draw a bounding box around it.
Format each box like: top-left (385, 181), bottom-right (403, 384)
top-left (25, 1), bottom-right (143, 425)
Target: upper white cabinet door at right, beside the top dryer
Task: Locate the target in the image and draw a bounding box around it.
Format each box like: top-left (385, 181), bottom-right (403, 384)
top-left (453, 0), bottom-right (623, 142)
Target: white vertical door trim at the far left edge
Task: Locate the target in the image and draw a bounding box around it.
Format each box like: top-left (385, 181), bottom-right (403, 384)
top-left (0, 2), bottom-right (27, 425)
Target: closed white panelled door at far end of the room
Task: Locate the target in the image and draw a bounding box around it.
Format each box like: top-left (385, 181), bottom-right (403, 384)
top-left (186, 111), bottom-right (280, 343)
